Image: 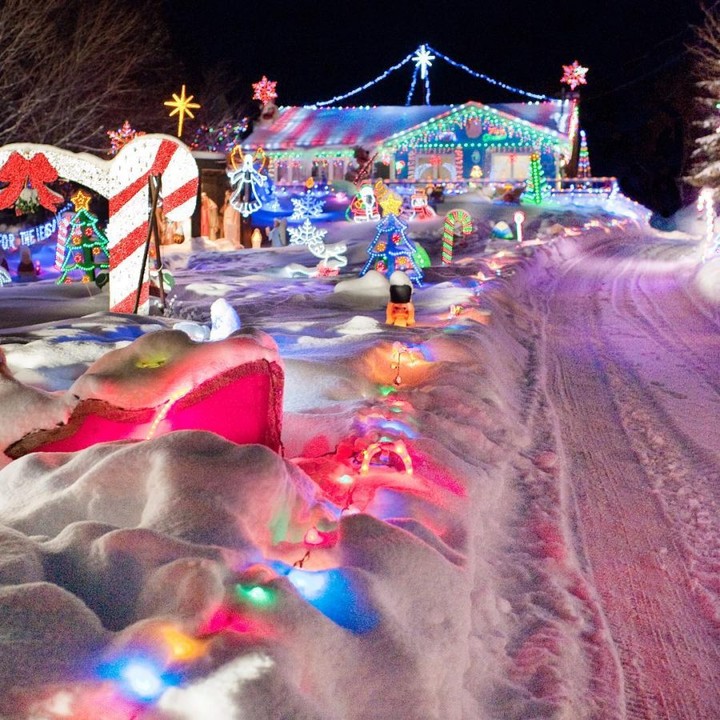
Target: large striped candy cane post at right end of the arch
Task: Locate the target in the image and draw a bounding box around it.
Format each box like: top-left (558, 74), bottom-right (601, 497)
top-left (107, 135), bottom-right (198, 315)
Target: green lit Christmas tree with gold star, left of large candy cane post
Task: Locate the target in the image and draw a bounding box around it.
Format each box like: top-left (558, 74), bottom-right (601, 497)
top-left (57, 190), bottom-right (110, 287)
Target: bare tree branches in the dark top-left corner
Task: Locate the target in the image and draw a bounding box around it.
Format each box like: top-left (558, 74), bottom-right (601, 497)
top-left (0, 0), bottom-right (174, 150)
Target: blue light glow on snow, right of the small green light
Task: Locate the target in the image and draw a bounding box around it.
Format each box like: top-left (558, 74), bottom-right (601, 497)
top-left (273, 562), bottom-right (379, 635)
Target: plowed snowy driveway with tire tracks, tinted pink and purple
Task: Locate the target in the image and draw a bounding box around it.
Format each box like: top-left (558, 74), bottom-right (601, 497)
top-left (526, 235), bottom-right (720, 720)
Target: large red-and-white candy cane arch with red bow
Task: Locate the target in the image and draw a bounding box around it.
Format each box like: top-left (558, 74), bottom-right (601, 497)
top-left (0, 135), bottom-right (198, 314)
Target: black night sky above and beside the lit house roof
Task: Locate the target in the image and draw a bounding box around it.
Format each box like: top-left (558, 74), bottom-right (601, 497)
top-left (167, 0), bottom-right (702, 214)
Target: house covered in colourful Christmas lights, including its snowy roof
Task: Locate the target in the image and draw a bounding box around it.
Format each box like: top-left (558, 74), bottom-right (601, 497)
top-left (242, 96), bottom-right (578, 185)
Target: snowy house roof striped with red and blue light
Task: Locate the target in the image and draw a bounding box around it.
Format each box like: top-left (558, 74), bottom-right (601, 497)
top-left (242, 100), bottom-right (567, 151)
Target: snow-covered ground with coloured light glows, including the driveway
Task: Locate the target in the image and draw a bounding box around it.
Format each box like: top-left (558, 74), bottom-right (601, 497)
top-left (0, 193), bottom-right (720, 720)
